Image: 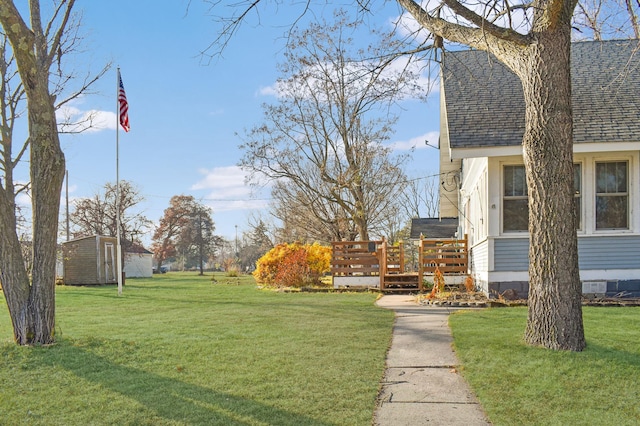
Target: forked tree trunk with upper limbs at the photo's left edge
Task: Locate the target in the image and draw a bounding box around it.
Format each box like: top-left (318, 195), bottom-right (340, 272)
top-left (0, 0), bottom-right (67, 345)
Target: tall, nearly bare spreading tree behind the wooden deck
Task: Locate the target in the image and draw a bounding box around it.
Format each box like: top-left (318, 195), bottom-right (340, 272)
top-left (240, 12), bottom-right (424, 240)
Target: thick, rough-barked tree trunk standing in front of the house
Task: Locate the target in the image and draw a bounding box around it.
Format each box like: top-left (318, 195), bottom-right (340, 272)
top-left (518, 33), bottom-right (586, 351)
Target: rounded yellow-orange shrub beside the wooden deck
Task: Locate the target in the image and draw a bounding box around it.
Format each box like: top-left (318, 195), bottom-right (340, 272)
top-left (253, 243), bottom-right (331, 287)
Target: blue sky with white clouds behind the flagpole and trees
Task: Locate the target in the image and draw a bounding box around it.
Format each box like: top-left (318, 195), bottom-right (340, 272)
top-left (51, 0), bottom-right (439, 244)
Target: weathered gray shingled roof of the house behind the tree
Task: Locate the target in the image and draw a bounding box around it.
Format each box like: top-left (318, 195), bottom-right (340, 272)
top-left (443, 40), bottom-right (640, 149)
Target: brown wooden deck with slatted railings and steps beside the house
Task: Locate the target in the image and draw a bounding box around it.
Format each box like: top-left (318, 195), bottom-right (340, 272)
top-left (331, 235), bottom-right (468, 292)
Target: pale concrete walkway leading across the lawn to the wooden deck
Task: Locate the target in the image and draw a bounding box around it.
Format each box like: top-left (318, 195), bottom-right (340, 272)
top-left (373, 295), bottom-right (490, 426)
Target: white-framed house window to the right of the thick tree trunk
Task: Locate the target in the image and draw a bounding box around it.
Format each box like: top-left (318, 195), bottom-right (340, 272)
top-left (596, 161), bottom-right (629, 229)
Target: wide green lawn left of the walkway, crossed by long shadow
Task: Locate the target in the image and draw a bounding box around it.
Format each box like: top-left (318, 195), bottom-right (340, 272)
top-left (0, 273), bottom-right (393, 426)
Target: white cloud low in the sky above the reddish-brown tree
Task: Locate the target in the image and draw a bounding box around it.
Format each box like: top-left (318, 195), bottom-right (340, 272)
top-left (191, 166), bottom-right (268, 212)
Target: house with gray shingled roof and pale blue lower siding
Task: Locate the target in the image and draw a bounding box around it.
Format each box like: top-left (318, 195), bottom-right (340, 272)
top-left (439, 40), bottom-right (640, 296)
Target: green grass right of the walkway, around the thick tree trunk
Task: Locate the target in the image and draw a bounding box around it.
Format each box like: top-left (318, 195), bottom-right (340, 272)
top-left (450, 307), bottom-right (640, 425)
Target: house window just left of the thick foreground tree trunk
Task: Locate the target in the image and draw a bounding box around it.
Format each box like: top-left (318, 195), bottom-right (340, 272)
top-left (502, 165), bottom-right (529, 232)
